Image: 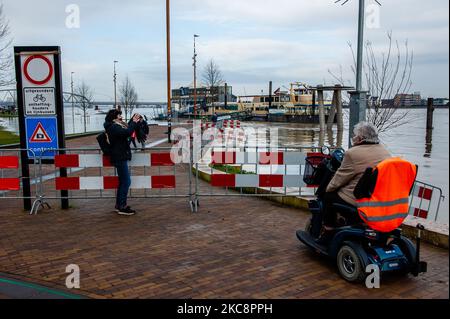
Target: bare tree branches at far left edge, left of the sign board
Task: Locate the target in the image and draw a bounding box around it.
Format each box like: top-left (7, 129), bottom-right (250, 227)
top-left (0, 4), bottom-right (14, 87)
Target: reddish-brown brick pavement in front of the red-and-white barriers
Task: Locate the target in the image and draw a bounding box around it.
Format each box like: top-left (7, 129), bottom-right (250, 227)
top-left (0, 127), bottom-right (449, 299)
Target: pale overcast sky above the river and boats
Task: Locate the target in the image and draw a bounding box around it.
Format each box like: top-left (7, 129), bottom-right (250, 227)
top-left (0, 0), bottom-right (449, 101)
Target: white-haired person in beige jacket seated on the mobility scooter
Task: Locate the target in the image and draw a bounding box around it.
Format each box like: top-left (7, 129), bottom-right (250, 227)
top-left (323, 122), bottom-right (392, 232)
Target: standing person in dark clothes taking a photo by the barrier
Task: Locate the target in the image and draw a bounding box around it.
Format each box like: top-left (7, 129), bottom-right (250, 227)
top-left (103, 109), bottom-right (141, 216)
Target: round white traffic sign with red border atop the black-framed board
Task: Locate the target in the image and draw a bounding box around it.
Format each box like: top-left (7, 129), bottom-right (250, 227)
top-left (23, 55), bottom-right (53, 85)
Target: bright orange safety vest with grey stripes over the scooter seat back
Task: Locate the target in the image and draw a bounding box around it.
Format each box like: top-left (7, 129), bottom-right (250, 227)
top-left (356, 157), bottom-right (417, 233)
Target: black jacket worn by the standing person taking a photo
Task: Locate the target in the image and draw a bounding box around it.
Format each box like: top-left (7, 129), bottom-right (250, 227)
top-left (103, 122), bottom-right (136, 164)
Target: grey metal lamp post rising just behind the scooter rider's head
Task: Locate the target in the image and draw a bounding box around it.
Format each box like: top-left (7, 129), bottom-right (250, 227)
top-left (335, 0), bottom-right (381, 147)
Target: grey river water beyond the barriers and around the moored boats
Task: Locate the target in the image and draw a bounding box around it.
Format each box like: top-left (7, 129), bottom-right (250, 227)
top-left (0, 108), bottom-right (449, 223)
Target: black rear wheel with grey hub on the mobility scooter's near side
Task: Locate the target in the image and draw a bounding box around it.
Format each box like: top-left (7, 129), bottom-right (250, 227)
top-left (336, 245), bottom-right (366, 282)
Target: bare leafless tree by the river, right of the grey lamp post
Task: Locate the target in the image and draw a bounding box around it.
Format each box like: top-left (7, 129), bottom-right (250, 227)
top-left (328, 32), bottom-right (414, 132)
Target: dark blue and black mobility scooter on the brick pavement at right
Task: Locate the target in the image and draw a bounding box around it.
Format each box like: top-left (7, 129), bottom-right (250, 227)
top-left (297, 147), bottom-right (427, 282)
